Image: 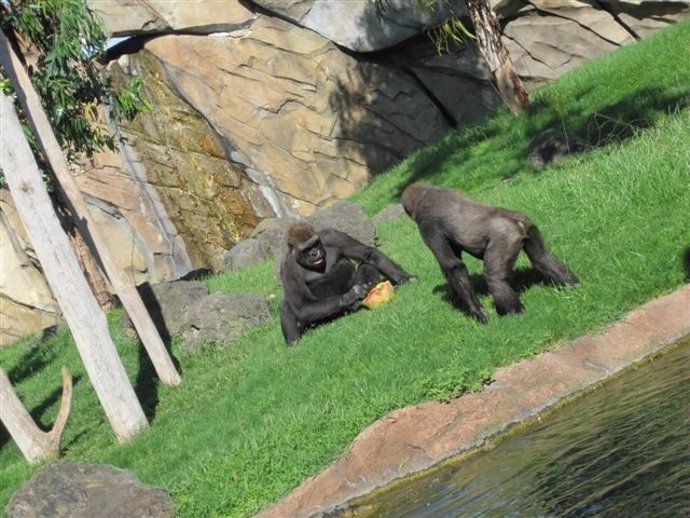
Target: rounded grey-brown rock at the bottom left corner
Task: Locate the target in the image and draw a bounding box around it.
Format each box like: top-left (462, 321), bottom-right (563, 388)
top-left (5, 462), bottom-right (175, 518)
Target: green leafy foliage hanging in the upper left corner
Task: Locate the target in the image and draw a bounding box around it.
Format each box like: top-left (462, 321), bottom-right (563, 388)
top-left (0, 0), bottom-right (151, 175)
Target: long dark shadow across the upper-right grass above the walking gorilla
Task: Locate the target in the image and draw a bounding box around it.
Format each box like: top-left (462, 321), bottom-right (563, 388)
top-left (394, 88), bottom-right (688, 197)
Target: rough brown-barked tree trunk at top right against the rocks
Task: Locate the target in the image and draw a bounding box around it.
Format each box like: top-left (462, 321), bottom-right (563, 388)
top-left (467, 0), bottom-right (529, 115)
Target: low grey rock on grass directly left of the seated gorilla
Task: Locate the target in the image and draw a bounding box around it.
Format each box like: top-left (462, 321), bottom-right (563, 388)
top-left (181, 293), bottom-right (270, 353)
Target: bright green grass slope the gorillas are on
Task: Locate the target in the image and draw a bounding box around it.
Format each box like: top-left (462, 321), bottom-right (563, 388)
top-left (0, 23), bottom-right (690, 518)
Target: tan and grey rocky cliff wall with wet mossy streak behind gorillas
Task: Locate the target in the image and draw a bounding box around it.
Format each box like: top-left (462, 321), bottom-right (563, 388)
top-left (0, 0), bottom-right (690, 350)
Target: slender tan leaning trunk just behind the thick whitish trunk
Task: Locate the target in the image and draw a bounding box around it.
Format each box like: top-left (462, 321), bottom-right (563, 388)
top-left (0, 30), bottom-right (182, 385)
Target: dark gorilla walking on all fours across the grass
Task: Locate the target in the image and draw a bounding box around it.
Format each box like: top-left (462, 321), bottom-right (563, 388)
top-left (402, 183), bottom-right (578, 322)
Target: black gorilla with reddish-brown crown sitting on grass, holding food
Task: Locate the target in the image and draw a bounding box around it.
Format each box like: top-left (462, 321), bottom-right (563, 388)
top-left (280, 223), bottom-right (414, 346)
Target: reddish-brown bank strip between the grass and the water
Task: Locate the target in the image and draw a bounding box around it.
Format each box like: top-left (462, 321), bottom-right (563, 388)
top-left (258, 285), bottom-right (690, 518)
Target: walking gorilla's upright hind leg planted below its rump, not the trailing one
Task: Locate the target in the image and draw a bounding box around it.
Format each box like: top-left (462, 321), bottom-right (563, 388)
top-left (484, 230), bottom-right (523, 315)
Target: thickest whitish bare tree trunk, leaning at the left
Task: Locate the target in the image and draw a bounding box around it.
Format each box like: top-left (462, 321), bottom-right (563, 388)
top-left (0, 92), bottom-right (148, 441)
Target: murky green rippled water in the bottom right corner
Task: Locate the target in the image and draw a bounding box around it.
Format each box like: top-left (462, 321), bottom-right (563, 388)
top-left (339, 339), bottom-right (690, 518)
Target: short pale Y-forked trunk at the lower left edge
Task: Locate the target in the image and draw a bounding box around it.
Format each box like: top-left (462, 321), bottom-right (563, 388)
top-left (0, 366), bottom-right (72, 463)
